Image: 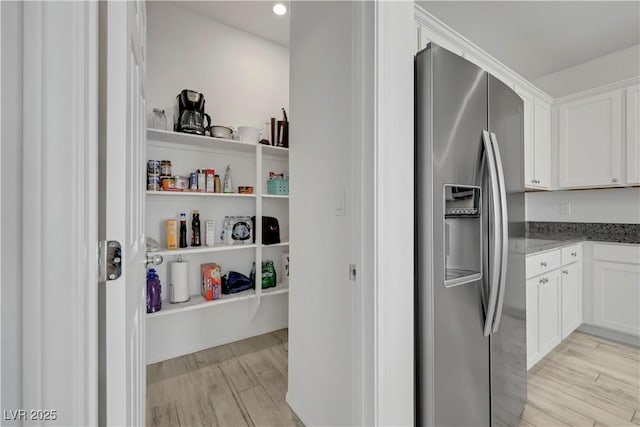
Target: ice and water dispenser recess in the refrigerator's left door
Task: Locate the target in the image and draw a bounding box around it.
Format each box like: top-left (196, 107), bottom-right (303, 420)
top-left (443, 184), bottom-right (482, 287)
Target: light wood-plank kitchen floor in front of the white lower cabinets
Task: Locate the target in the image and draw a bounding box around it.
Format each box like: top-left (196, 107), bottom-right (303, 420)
top-left (520, 332), bottom-right (640, 427)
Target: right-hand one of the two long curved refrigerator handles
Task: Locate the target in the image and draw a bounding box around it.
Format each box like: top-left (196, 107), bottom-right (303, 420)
top-left (491, 132), bottom-right (509, 332)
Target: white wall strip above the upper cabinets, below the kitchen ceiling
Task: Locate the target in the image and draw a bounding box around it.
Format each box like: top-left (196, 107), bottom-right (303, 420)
top-left (532, 44), bottom-right (640, 98)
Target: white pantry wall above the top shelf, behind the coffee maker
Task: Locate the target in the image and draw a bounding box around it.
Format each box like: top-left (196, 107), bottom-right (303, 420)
top-left (147, 2), bottom-right (289, 129)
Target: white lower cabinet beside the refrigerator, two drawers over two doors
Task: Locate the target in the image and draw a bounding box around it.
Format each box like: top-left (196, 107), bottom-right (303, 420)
top-left (526, 244), bottom-right (583, 369)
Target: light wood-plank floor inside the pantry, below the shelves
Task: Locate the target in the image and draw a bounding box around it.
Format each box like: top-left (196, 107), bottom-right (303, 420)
top-left (147, 329), bottom-right (304, 427)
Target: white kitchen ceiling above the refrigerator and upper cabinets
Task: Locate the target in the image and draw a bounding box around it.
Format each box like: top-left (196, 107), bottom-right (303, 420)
top-left (417, 1), bottom-right (640, 81)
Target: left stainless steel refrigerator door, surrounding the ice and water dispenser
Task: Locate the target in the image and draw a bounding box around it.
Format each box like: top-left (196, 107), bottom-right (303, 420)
top-left (415, 45), bottom-right (491, 426)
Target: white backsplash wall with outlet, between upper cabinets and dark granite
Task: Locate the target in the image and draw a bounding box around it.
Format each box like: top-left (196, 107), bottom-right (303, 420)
top-left (525, 187), bottom-right (640, 224)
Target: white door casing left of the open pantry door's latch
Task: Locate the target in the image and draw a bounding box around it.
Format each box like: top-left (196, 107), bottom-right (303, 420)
top-left (20, 2), bottom-right (98, 425)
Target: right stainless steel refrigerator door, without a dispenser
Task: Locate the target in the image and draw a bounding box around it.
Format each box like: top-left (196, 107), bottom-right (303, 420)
top-left (489, 76), bottom-right (527, 426)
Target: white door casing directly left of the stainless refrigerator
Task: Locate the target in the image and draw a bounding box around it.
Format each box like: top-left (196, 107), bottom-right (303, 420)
top-left (373, 1), bottom-right (416, 426)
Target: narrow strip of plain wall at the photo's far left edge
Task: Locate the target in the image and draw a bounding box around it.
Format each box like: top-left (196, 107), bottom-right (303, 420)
top-left (0, 1), bottom-right (23, 425)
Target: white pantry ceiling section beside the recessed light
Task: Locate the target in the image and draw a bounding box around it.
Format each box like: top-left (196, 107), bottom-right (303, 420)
top-left (174, 0), bottom-right (289, 46)
